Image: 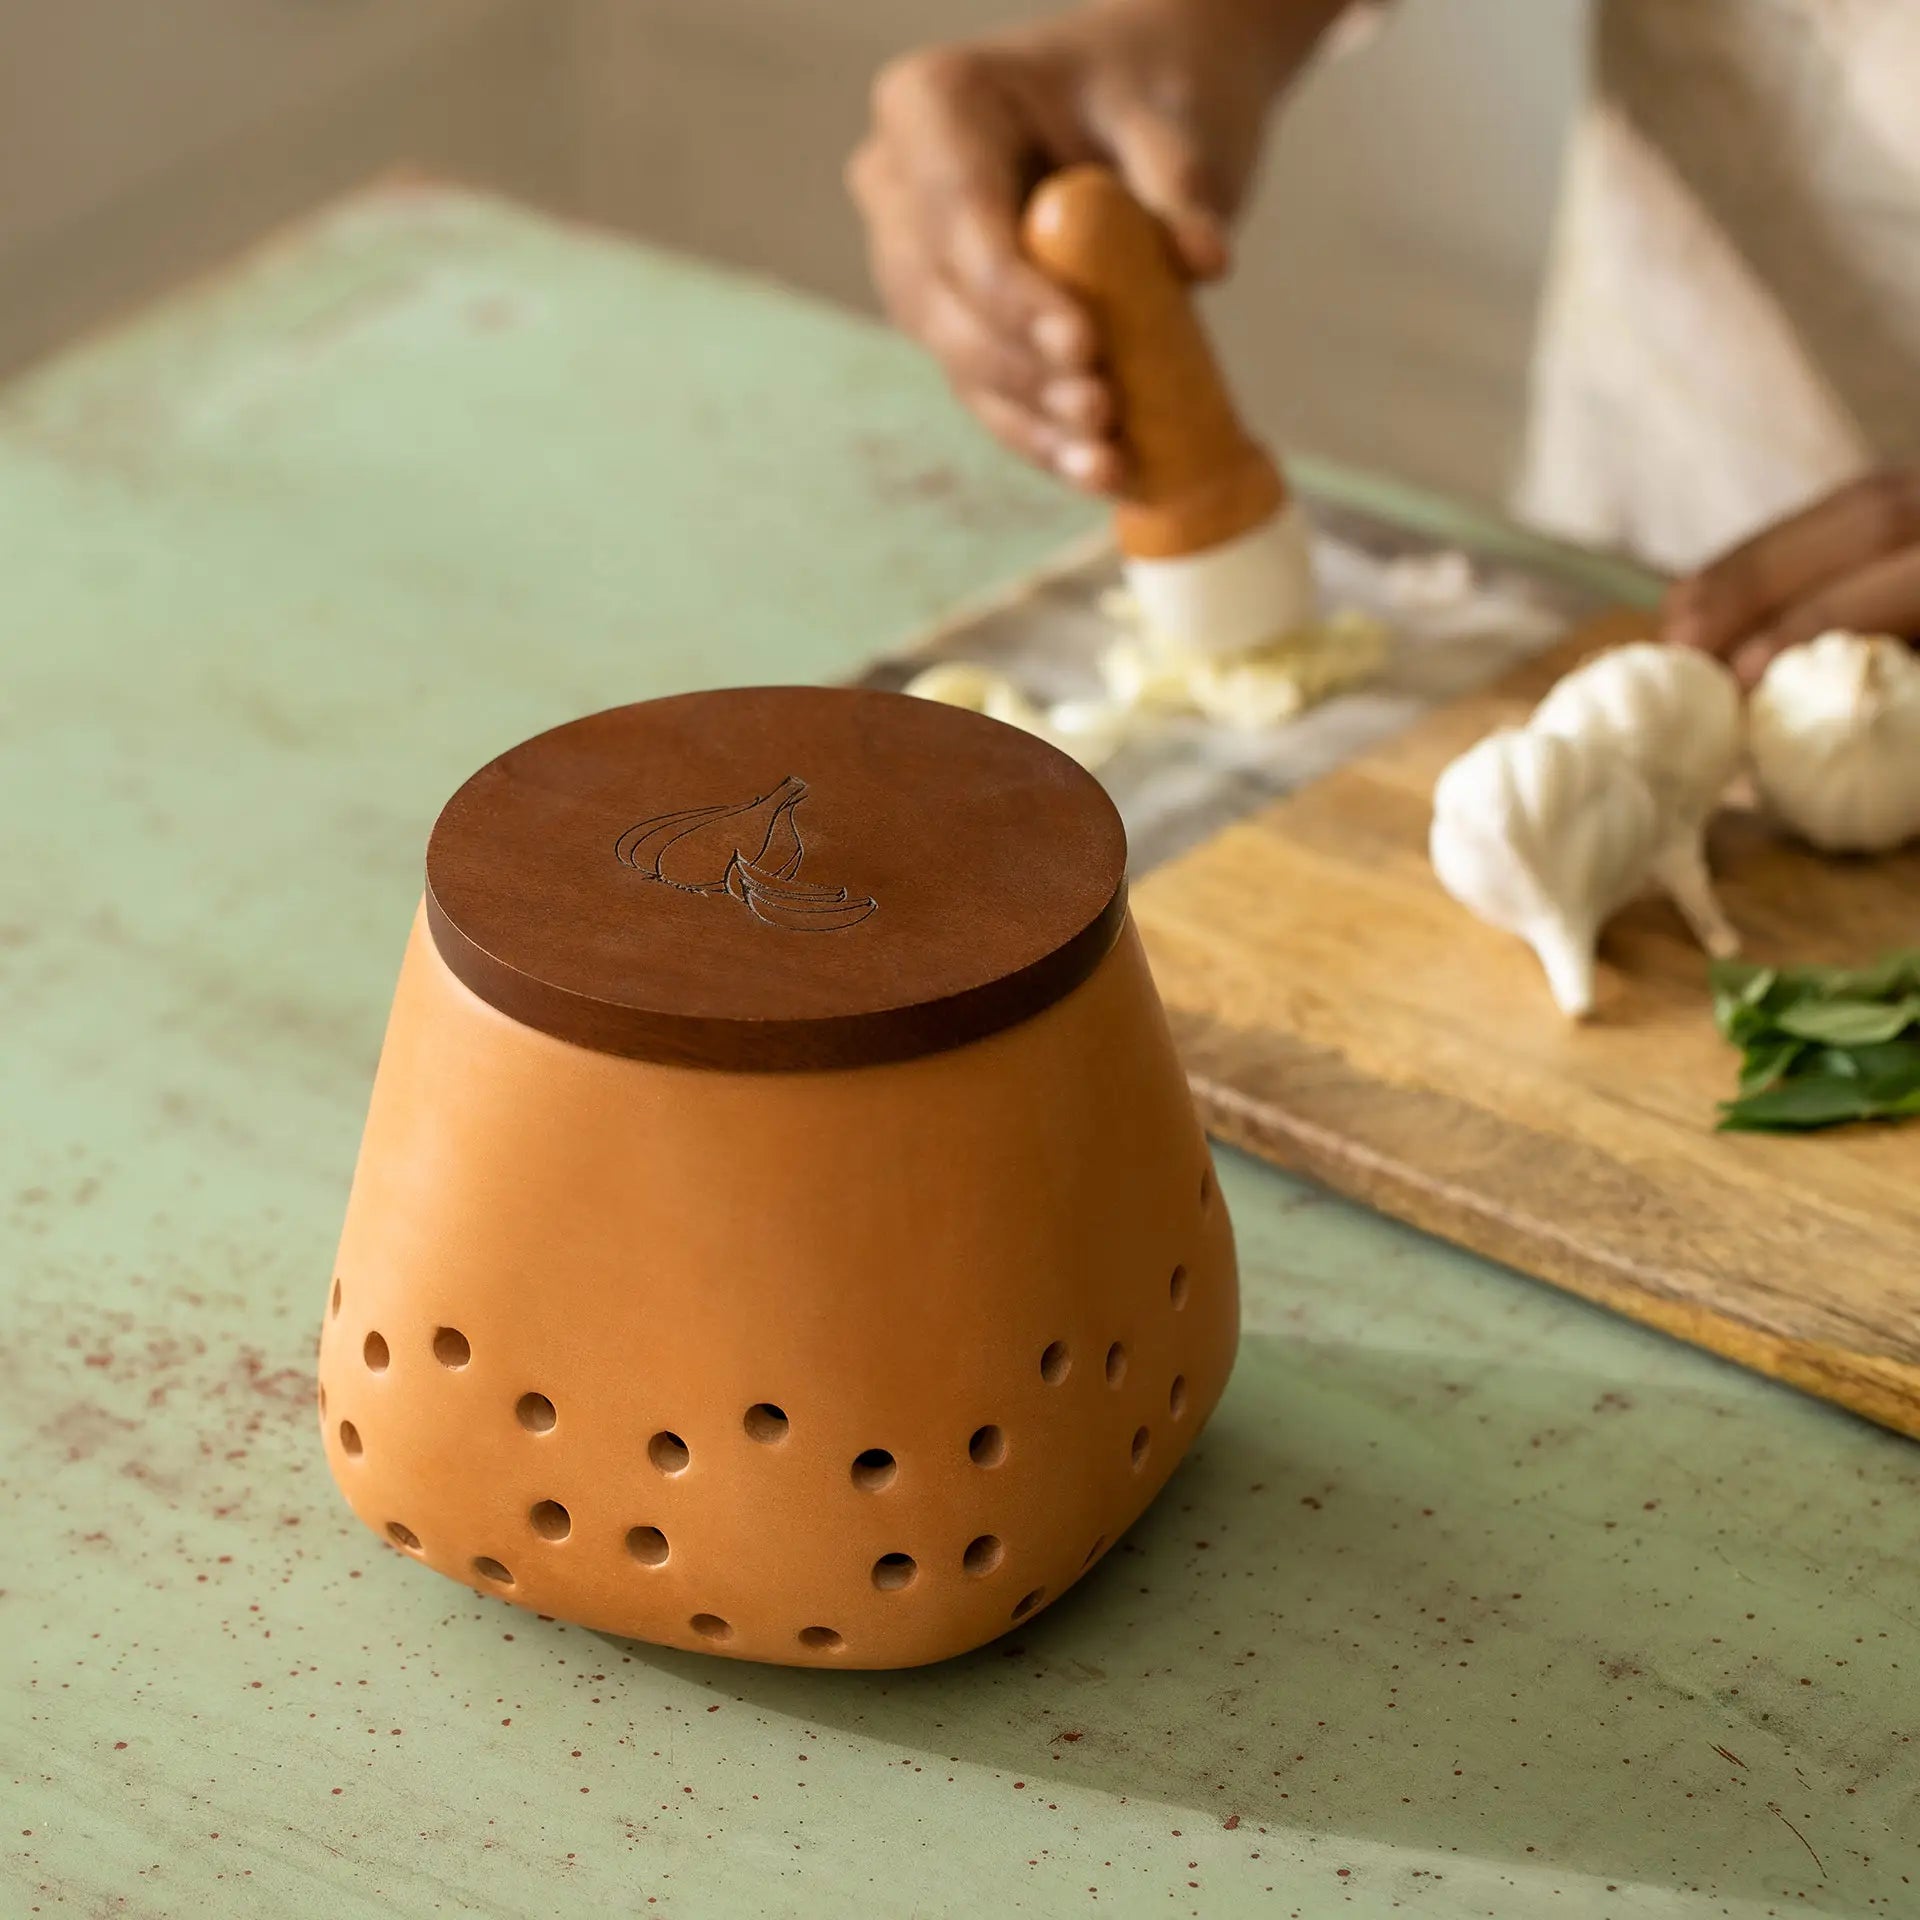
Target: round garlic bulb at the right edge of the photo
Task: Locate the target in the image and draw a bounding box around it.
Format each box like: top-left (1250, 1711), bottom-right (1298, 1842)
top-left (1747, 634), bottom-right (1920, 852)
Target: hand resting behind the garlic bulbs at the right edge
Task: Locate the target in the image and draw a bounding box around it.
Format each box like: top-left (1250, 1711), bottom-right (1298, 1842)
top-left (1661, 468), bottom-right (1920, 687)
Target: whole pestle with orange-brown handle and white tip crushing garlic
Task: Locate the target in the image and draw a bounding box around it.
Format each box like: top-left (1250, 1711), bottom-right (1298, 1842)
top-left (1021, 165), bottom-right (1313, 653)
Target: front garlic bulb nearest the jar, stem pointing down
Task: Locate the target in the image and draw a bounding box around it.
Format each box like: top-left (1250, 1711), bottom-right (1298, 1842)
top-left (1428, 728), bottom-right (1663, 1018)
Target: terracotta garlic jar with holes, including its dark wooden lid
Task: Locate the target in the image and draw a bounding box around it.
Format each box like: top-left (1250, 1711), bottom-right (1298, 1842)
top-left (319, 687), bottom-right (1238, 1667)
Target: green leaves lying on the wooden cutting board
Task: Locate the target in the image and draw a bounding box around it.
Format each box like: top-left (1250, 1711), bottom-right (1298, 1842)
top-left (1713, 950), bottom-right (1920, 1133)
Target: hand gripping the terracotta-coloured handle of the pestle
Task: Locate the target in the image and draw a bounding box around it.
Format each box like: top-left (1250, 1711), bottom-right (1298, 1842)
top-left (847, 0), bottom-right (1342, 493)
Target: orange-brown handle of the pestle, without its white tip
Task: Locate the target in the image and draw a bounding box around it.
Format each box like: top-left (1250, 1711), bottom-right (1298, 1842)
top-left (1021, 165), bottom-right (1286, 559)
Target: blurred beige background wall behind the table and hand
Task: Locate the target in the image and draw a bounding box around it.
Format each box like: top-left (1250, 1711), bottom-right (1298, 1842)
top-left (0, 0), bottom-right (1584, 497)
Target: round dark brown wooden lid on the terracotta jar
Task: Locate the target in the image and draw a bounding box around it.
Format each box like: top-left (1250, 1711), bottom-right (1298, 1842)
top-left (426, 687), bottom-right (1127, 1071)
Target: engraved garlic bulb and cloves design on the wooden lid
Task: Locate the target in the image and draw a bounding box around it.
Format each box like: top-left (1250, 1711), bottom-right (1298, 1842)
top-left (614, 774), bottom-right (879, 933)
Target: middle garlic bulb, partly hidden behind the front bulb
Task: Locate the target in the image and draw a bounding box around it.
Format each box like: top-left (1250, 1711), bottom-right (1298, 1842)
top-left (1528, 641), bottom-right (1745, 960)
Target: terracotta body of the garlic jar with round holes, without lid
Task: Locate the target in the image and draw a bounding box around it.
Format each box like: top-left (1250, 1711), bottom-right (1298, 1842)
top-left (321, 902), bottom-right (1238, 1667)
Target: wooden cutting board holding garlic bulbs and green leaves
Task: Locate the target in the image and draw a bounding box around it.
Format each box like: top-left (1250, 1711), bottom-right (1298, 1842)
top-left (1135, 616), bottom-right (1920, 1436)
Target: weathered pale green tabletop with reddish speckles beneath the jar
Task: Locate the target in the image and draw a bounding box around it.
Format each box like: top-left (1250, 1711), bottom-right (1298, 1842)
top-left (0, 188), bottom-right (1920, 1920)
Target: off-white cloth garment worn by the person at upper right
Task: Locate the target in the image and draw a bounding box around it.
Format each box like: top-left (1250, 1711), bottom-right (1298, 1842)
top-left (1517, 0), bottom-right (1920, 568)
